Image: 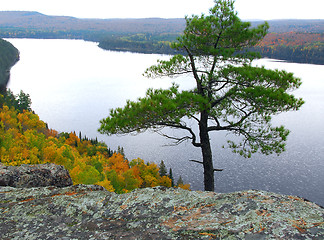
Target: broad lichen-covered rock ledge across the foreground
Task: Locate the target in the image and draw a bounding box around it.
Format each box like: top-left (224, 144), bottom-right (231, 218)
top-left (0, 185), bottom-right (324, 240)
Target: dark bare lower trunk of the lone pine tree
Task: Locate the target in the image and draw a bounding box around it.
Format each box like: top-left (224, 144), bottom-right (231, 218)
top-left (199, 112), bottom-right (215, 191)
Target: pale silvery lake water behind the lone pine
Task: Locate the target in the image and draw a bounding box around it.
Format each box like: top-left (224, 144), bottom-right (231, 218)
top-left (7, 39), bottom-right (324, 206)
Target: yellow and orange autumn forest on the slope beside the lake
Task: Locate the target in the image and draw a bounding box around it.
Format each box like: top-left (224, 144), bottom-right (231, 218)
top-left (0, 89), bottom-right (190, 193)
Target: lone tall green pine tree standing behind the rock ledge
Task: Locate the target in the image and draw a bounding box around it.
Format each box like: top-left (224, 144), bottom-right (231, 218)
top-left (99, 0), bottom-right (304, 191)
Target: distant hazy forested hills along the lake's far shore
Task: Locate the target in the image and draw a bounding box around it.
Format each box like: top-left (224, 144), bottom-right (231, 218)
top-left (0, 11), bottom-right (324, 64)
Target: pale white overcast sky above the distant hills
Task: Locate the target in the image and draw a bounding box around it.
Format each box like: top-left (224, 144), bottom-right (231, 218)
top-left (0, 0), bottom-right (324, 20)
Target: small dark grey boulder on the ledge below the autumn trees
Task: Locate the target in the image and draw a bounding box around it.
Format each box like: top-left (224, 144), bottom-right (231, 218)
top-left (0, 163), bottom-right (73, 188)
